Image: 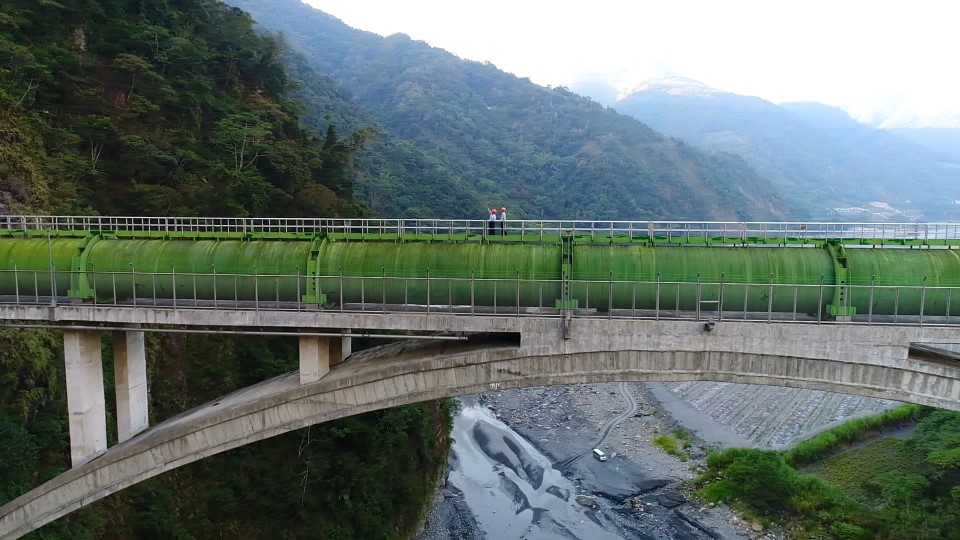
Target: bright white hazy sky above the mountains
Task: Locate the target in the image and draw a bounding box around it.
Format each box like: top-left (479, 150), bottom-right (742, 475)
top-left (306, 0), bottom-right (960, 123)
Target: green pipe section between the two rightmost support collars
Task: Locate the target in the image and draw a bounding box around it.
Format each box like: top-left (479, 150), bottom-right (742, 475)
top-left (573, 246), bottom-right (834, 314)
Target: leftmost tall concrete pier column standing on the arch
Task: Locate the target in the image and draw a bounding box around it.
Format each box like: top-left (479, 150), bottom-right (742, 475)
top-left (63, 330), bottom-right (107, 467)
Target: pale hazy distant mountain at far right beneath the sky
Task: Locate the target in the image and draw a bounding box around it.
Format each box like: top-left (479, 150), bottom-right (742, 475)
top-left (614, 77), bottom-right (960, 220)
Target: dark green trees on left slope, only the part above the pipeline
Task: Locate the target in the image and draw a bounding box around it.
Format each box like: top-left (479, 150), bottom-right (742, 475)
top-left (0, 0), bottom-right (365, 216)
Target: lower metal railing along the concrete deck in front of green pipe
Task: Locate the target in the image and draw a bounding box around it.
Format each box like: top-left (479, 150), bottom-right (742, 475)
top-left (0, 268), bottom-right (960, 325)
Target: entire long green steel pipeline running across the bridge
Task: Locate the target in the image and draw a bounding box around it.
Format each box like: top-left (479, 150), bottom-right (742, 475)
top-left (0, 235), bottom-right (960, 315)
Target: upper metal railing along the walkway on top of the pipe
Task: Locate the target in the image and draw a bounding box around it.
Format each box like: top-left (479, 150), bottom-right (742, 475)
top-left (0, 215), bottom-right (960, 243)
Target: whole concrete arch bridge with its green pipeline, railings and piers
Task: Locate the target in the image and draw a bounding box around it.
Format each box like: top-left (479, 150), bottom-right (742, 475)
top-left (0, 218), bottom-right (960, 538)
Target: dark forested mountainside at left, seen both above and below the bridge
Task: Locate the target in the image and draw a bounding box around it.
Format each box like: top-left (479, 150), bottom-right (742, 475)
top-left (0, 0), bottom-right (450, 539)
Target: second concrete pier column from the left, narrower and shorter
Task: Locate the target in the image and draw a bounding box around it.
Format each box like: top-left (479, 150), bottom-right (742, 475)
top-left (113, 330), bottom-right (150, 442)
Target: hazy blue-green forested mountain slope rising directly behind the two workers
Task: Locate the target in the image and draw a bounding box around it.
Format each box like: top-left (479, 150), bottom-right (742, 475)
top-left (231, 0), bottom-right (801, 219)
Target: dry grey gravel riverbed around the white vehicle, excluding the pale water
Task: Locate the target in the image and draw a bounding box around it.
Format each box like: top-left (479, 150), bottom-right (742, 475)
top-left (414, 382), bottom-right (896, 540)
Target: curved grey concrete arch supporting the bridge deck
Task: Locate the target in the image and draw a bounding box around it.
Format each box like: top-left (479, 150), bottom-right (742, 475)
top-left (0, 321), bottom-right (960, 538)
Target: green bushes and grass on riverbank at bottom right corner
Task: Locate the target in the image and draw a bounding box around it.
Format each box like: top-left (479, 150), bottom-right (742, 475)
top-left (698, 405), bottom-right (960, 540)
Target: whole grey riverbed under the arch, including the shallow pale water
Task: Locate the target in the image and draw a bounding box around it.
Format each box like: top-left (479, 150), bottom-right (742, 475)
top-left (415, 383), bottom-right (892, 540)
